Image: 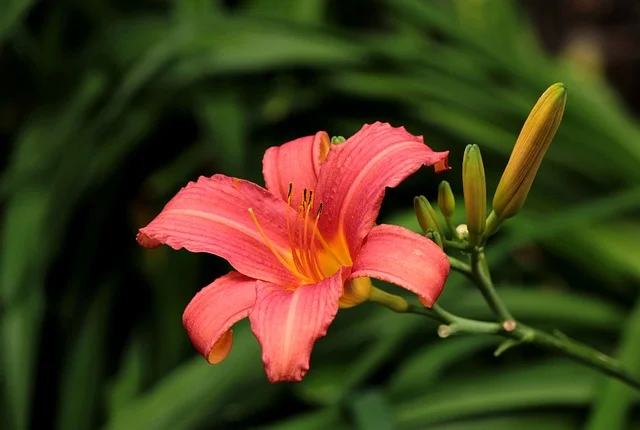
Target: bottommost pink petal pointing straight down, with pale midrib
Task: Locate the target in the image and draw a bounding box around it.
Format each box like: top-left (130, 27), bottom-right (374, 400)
top-left (249, 270), bottom-right (342, 382)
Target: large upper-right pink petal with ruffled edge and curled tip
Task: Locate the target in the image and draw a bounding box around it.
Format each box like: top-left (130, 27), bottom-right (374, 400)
top-left (316, 122), bottom-right (449, 255)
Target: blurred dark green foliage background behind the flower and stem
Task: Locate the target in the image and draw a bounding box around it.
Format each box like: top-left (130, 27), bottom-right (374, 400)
top-left (0, 0), bottom-right (640, 430)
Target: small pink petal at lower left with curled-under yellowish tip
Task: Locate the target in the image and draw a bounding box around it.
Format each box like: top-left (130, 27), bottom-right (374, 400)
top-left (182, 272), bottom-right (257, 364)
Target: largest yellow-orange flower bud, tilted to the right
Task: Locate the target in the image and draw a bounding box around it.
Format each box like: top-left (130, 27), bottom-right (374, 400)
top-left (493, 83), bottom-right (567, 222)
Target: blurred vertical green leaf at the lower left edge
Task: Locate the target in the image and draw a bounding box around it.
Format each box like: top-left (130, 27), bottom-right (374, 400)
top-left (0, 189), bottom-right (50, 430)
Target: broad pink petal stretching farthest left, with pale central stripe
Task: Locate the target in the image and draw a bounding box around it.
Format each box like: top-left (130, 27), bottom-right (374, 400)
top-left (137, 175), bottom-right (298, 285)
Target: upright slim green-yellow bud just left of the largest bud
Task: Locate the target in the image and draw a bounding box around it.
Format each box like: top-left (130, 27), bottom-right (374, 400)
top-left (462, 145), bottom-right (487, 245)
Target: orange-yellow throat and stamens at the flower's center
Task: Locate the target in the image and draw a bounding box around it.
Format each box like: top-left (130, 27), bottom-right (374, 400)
top-left (249, 183), bottom-right (352, 284)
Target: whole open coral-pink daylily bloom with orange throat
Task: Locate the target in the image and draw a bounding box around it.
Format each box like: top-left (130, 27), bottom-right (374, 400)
top-left (137, 123), bottom-right (449, 382)
